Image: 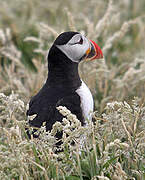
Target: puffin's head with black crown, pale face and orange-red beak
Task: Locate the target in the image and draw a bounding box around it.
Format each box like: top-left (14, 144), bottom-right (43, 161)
top-left (48, 31), bottom-right (103, 63)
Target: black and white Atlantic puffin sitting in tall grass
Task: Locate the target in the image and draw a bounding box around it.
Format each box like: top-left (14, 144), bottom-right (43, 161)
top-left (27, 31), bottom-right (103, 137)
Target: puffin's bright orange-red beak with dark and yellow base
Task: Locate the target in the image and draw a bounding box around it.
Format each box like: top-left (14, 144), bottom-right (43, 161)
top-left (85, 40), bottom-right (103, 61)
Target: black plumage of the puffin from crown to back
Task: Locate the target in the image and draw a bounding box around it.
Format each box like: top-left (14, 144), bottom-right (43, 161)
top-left (27, 32), bottom-right (84, 137)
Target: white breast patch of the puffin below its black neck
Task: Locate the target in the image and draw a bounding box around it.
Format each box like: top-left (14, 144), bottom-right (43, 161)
top-left (76, 81), bottom-right (94, 120)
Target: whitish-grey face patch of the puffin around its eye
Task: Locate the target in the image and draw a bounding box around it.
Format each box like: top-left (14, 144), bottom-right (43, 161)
top-left (56, 34), bottom-right (91, 63)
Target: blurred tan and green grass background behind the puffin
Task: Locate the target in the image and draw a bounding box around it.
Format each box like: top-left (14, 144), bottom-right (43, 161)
top-left (0, 0), bottom-right (145, 113)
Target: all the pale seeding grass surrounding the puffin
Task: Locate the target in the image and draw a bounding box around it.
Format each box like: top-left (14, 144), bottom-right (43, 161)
top-left (0, 0), bottom-right (145, 180)
